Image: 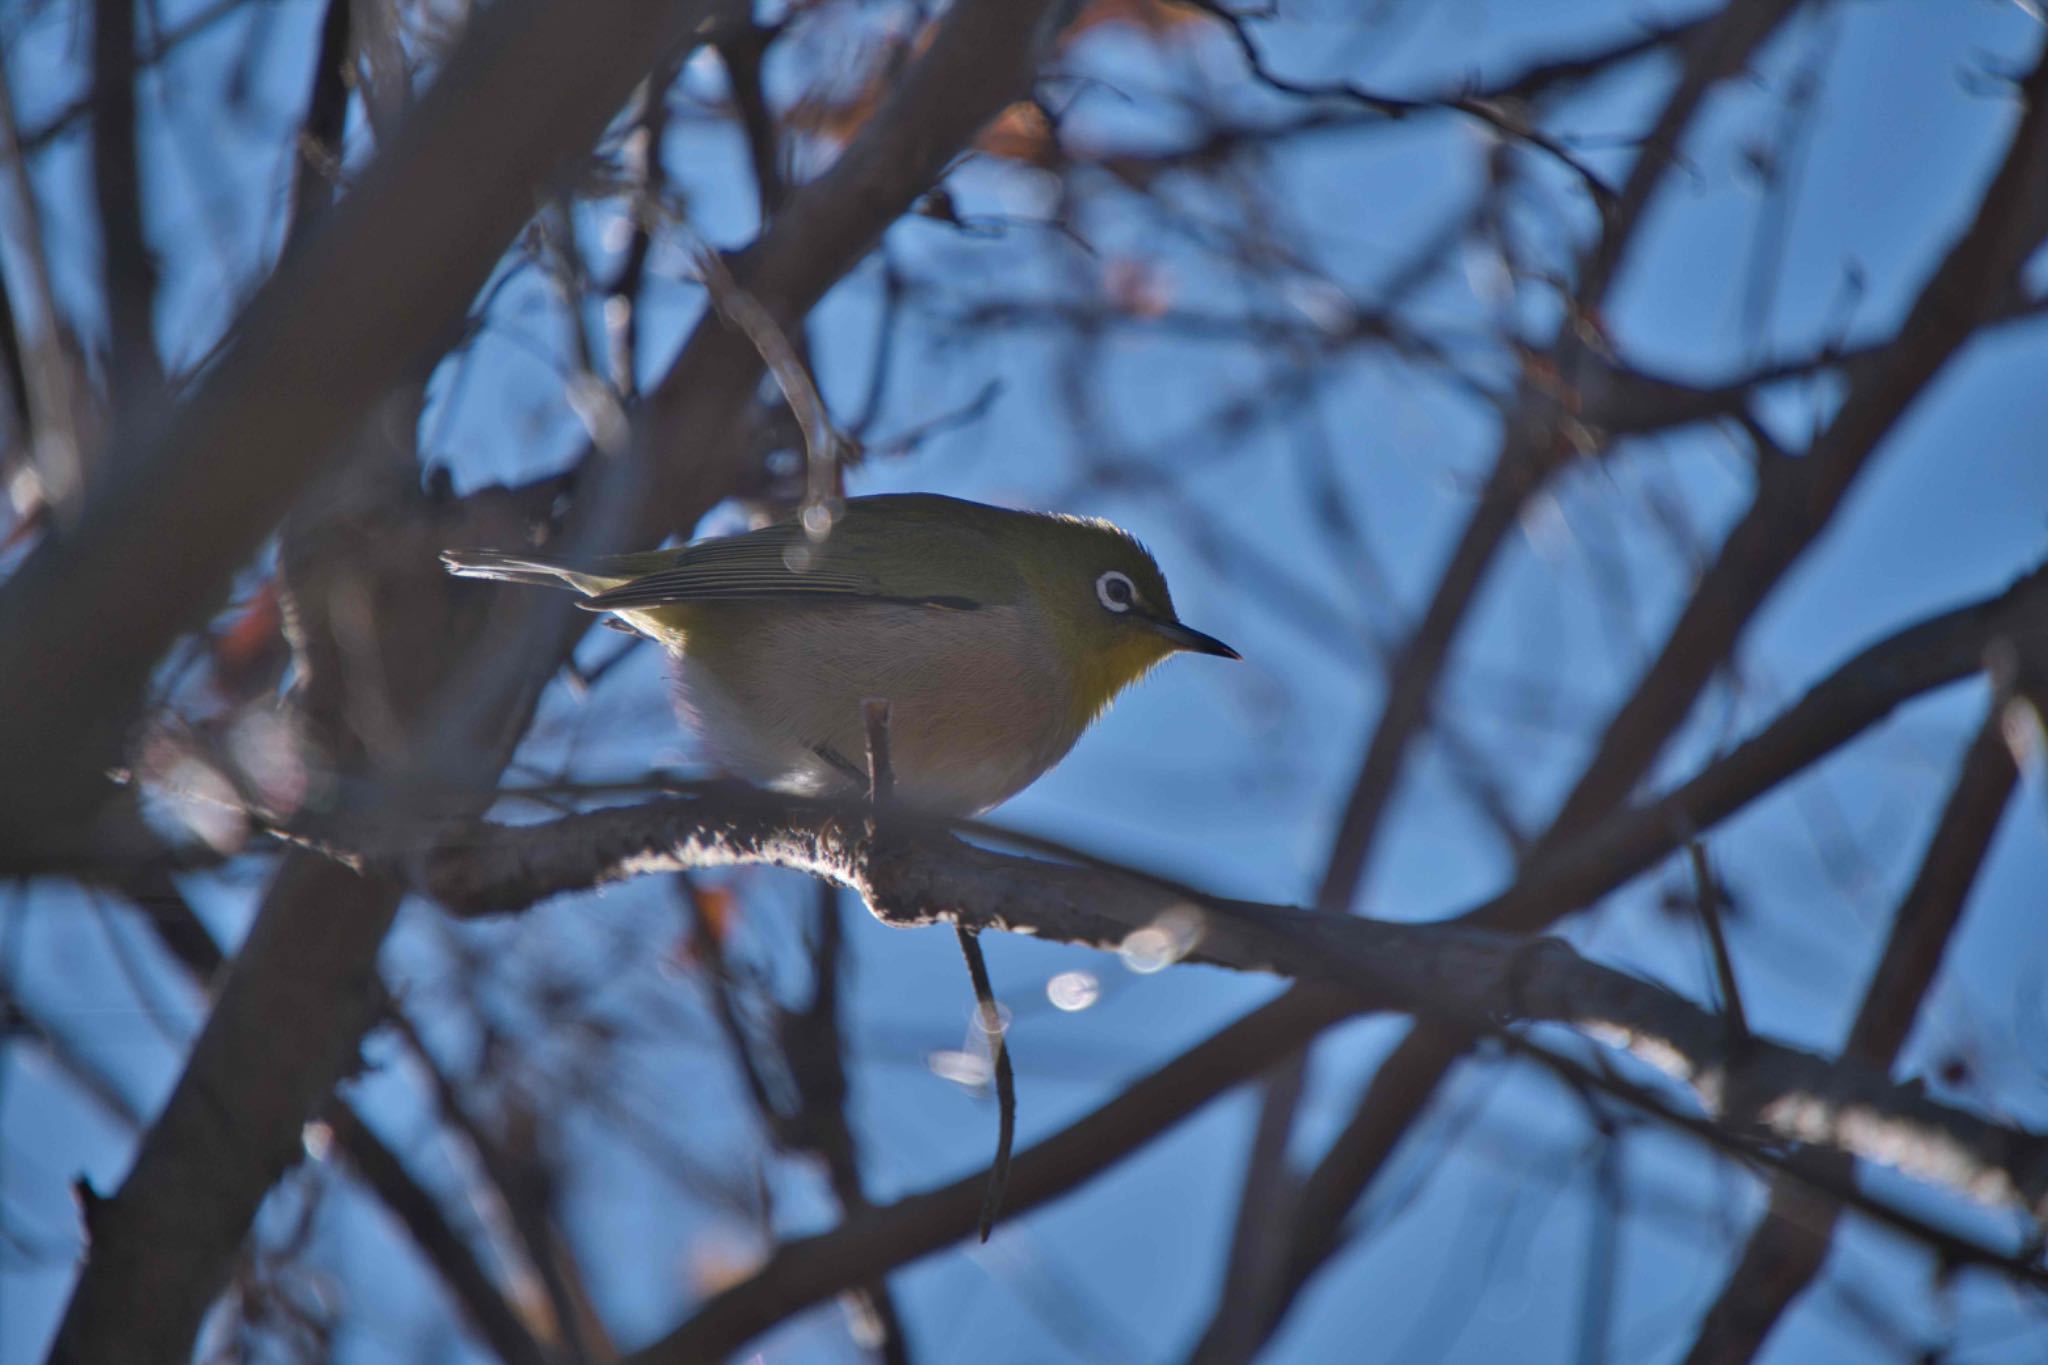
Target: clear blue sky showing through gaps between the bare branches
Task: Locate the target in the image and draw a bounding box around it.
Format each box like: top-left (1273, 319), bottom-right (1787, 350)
top-left (0, 0), bottom-right (2048, 1361)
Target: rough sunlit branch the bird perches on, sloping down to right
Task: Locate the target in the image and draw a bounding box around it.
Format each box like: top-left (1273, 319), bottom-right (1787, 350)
top-left (407, 792), bottom-right (2048, 1214)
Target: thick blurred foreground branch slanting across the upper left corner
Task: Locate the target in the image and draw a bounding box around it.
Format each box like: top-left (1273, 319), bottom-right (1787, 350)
top-left (0, 0), bottom-right (720, 868)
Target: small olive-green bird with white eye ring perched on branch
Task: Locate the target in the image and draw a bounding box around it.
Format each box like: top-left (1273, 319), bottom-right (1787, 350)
top-left (442, 493), bottom-right (1239, 814)
